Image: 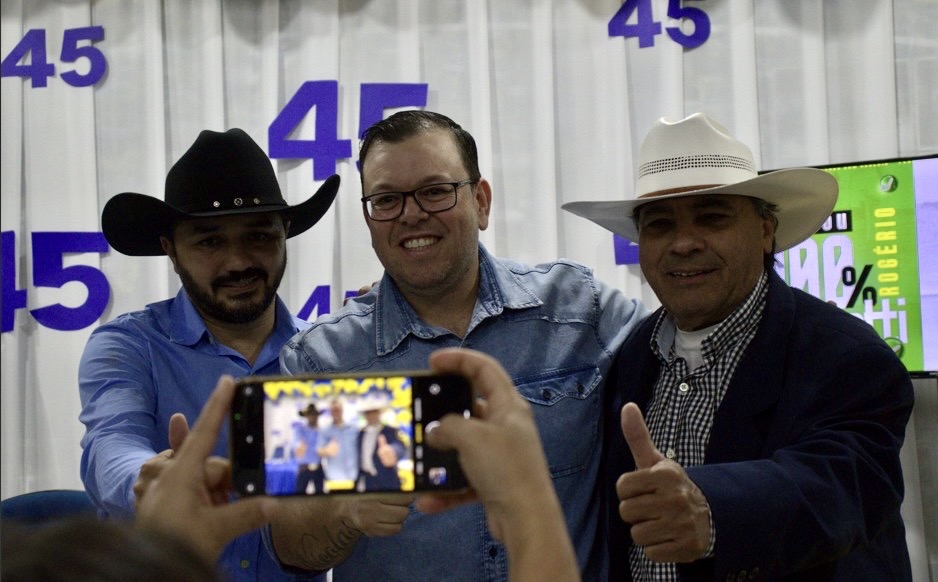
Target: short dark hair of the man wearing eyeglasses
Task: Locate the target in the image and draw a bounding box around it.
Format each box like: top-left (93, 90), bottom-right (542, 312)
top-left (358, 109), bottom-right (482, 182)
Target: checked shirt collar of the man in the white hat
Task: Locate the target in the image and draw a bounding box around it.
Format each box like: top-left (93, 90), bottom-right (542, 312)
top-left (650, 270), bottom-right (769, 362)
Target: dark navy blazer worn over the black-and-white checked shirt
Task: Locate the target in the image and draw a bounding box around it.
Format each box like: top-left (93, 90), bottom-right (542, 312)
top-left (603, 272), bottom-right (913, 582)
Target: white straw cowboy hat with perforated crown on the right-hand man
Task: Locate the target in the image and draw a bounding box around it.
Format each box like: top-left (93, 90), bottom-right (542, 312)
top-left (561, 113), bottom-right (837, 252)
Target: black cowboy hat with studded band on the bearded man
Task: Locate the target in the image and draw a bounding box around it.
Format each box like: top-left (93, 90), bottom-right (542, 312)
top-left (101, 128), bottom-right (339, 256)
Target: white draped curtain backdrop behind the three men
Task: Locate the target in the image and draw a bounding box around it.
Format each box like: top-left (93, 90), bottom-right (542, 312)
top-left (0, 0), bottom-right (938, 576)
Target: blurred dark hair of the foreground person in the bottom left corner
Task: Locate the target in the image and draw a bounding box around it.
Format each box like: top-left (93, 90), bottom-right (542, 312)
top-left (0, 516), bottom-right (220, 582)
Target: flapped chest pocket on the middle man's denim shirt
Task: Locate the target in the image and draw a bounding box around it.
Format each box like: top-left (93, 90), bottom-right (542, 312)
top-left (515, 366), bottom-right (603, 478)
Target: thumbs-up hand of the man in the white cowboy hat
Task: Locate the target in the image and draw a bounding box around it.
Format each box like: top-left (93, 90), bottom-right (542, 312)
top-left (616, 402), bottom-right (710, 562)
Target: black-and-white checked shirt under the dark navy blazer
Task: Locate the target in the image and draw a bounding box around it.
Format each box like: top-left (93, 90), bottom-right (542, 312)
top-left (629, 271), bottom-right (769, 582)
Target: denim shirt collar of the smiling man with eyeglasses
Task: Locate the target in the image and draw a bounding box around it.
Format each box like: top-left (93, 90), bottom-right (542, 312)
top-left (375, 243), bottom-right (543, 356)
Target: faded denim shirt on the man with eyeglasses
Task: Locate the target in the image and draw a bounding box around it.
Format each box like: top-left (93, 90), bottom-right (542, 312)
top-left (280, 245), bottom-right (647, 582)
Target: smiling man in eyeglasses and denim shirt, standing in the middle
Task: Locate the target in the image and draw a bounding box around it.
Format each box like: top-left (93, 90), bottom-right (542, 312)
top-left (274, 111), bottom-right (647, 581)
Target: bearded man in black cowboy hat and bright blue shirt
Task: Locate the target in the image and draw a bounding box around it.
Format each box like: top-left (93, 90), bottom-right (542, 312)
top-left (79, 129), bottom-right (339, 580)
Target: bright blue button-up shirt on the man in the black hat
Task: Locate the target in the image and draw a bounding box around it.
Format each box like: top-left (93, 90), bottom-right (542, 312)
top-left (78, 290), bottom-right (318, 581)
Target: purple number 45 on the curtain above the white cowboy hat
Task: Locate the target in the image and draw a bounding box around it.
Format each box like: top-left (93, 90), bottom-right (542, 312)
top-left (609, 0), bottom-right (710, 49)
